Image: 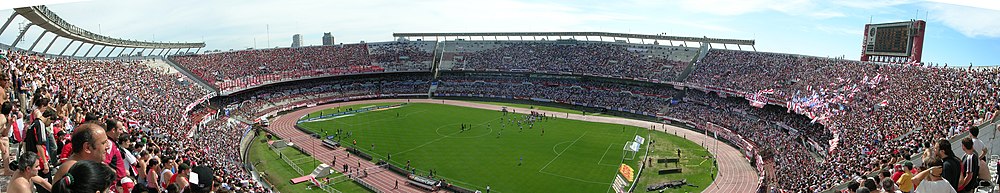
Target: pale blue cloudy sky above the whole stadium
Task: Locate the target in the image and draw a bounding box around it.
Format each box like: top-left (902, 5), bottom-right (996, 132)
top-left (0, 0), bottom-right (1000, 66)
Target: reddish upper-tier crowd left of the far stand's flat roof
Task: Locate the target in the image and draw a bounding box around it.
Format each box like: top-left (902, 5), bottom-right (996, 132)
top-left (171, 41), bottom-right (433, 91)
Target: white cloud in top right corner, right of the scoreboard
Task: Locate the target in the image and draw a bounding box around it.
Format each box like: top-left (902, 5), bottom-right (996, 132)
top-left (922, 3), bottom-right (1000, 38)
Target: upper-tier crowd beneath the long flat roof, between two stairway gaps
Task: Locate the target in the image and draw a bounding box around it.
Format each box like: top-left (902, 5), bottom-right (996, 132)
top-left (445, 42), bottom-right (690, 82)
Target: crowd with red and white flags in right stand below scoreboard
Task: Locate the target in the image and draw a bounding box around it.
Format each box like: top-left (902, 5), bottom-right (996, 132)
top-left (688, 50), bottom-right (1000, 190)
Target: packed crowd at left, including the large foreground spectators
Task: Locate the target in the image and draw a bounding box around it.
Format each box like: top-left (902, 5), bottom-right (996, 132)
top-left (0, 50), bottom-right (264, 192)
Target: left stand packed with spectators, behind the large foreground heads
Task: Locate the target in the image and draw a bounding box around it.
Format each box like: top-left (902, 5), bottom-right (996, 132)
top-left (0, 50), bottom-right (264, 192)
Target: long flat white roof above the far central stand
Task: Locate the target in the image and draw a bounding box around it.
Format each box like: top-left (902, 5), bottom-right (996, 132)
top-left (392, 32), bottom-right (754, 46)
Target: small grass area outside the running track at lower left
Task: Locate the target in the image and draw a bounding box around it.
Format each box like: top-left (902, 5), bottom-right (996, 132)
top-left (248, 134), bottom-right (372, 193)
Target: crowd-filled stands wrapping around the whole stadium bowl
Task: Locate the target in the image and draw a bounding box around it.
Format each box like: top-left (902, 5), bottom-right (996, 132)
top-left (0, 39), bottom-right (1000, 192)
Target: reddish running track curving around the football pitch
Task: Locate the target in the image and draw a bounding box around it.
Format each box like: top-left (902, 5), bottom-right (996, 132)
top-left (268, 99), bottom-right (759, 193)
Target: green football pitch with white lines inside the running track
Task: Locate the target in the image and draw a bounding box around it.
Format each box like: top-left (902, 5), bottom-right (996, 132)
top-left (299, 103), bottom-right (711, 192)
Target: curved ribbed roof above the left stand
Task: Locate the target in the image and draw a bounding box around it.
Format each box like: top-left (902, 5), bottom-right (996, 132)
top-left (7, 6), bottom-right (205, 49)
